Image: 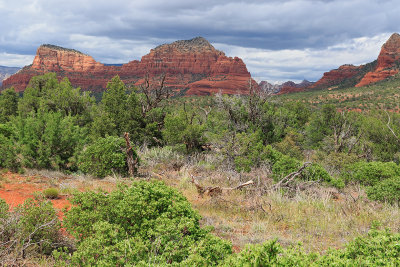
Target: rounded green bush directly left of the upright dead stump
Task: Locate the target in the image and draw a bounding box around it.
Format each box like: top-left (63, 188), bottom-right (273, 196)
top-left (78, 136), bottom-right (128, 177)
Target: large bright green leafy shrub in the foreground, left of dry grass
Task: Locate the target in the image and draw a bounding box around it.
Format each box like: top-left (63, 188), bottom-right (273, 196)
top-left (64, 181), bottom-right (232, 266)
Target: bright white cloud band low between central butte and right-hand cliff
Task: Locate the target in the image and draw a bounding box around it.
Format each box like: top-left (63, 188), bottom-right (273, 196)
top-left (215, 33), bottom-right (390, 83)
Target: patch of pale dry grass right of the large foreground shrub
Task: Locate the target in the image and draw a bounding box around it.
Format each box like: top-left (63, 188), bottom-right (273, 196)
top-left (137, 149), bottom-right (400, 252)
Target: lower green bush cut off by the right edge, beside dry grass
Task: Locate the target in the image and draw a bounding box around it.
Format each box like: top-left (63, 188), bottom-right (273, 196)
top-left (366, 176), bottom-right (400, 203)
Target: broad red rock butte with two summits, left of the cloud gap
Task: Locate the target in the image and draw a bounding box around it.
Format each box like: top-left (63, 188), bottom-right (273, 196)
top-left (3, 37), bottom-right (255, 95)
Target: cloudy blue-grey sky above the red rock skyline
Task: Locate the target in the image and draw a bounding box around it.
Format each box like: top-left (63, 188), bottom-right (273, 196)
top-left (0, 0), bottom-right (400, 83)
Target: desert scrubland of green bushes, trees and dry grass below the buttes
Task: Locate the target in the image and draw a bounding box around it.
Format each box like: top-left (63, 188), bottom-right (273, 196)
top-left (0, 74), bottom-right (400, 266)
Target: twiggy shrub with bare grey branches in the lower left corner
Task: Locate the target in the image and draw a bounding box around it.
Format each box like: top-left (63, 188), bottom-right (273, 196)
top-left (0, 197), bottom-right (61, 266)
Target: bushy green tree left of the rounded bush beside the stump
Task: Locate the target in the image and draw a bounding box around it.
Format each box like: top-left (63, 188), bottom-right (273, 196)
top-left (14, 112), bottom-right (86, 170)
